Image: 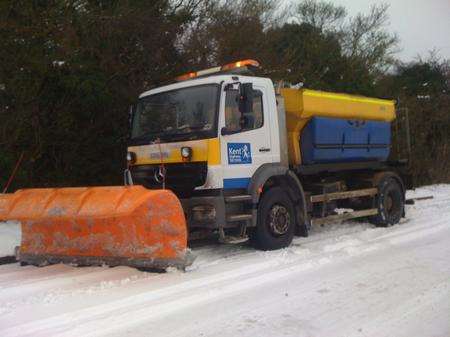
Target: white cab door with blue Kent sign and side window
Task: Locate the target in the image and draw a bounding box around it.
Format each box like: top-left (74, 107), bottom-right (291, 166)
top-left (219, 79), bottom-right (272, 189)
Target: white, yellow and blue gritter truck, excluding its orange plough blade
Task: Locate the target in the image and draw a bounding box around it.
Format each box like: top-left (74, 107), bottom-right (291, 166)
top-left (126, 60), bottom-right (405, 250)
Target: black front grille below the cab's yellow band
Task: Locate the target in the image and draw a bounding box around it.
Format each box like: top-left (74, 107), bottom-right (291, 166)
top-left (130, 162), bottom-right (208, 198)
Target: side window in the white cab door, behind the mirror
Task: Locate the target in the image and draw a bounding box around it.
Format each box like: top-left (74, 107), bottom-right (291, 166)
top-left (225, 90), bottom-right (264, 131)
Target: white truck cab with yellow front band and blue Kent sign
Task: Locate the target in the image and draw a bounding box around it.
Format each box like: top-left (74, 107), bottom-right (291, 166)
top-left (129, 69), bottom-right (286, 190)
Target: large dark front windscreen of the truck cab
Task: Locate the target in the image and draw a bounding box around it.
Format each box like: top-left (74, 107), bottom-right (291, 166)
top-left (131, 84), bottom-right (219, 140)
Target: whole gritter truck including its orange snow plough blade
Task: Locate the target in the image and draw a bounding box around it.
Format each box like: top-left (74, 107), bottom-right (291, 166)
top-left (0, 60), bottom-right (407, 269)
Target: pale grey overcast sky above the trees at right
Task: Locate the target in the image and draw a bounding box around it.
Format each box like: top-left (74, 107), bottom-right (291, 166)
top-left (294, 0), bottom-right (450, 61)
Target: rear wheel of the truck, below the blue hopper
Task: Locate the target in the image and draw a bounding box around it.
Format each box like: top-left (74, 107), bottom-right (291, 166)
top-left (369, 177), bottom-right (405, 227)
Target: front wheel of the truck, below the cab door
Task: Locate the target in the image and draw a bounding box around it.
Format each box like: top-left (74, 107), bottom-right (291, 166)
top-left (251, 187), bottom-right (296, 250)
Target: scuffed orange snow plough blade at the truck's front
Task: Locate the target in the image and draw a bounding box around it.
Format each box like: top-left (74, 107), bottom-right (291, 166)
top-left (0, 186), bottom-right (192, 269)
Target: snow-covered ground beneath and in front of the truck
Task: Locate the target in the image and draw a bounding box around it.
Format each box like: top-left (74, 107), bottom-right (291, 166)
top-left (0, 185), bottom-right (450, 337)
